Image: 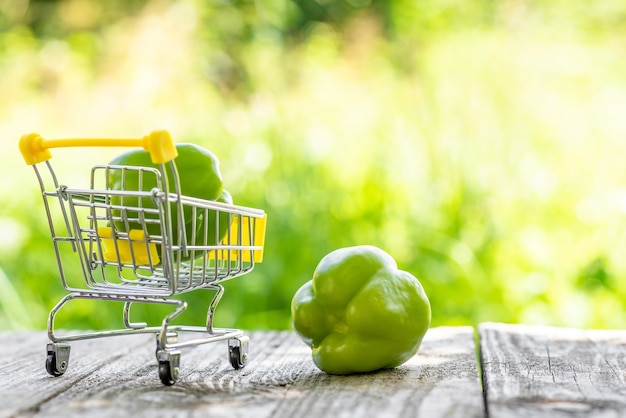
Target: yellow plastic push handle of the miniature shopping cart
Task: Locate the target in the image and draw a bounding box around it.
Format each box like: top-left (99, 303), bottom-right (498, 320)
top-left (20, 131), bottom-right (178, 165)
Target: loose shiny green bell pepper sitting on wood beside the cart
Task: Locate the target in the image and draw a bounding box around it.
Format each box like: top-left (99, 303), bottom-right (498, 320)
top-left (291, 246), bottom-right (431, 374)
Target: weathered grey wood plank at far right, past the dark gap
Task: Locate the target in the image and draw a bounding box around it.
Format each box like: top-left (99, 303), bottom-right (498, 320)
top-left (479, 324), bottom-right (626, 418)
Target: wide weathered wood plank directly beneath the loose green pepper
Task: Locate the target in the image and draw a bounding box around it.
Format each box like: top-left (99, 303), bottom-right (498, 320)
top-left (0, 327), bottom-right (484, 418)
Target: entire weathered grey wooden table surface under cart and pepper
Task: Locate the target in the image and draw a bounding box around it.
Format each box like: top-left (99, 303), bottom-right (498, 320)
top-left (0, 323), bottom-right (626, 418)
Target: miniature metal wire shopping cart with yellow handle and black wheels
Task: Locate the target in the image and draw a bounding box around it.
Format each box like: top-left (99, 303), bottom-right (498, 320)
top-left (20, 131), bottom-right (266, 385)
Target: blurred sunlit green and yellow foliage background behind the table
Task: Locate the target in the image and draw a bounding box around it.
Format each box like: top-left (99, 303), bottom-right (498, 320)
top-left (0, 0), bottom-right (626, 329)
